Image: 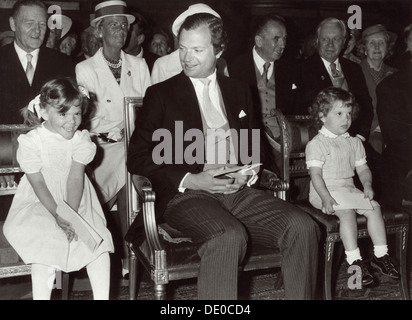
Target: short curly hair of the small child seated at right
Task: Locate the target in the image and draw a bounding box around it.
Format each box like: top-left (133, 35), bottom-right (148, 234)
top-left (309, 87), bottom-right (359, 128)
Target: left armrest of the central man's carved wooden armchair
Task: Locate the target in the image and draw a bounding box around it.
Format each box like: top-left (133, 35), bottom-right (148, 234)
top-left (132, 175), bottom-right (163, 253)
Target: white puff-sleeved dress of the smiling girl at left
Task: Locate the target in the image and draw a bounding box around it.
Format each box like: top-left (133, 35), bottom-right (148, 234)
top-left (4, 125), bottom-right (114, 272)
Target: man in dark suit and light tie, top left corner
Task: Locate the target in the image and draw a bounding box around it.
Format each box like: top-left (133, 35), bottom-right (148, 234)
top-left (0, 0), bottom-right (74, 124)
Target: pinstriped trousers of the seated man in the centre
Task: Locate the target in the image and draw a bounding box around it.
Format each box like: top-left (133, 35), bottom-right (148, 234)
top-left (164, 188), bottom-right (320, 300)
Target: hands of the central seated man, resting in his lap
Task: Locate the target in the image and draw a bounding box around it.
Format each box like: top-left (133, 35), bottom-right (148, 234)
top-left (183, 169), bottom-right (249, 194)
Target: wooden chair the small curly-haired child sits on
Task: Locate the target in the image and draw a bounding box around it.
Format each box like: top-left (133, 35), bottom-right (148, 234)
top-left (279, 116), bottom-right (409, 300)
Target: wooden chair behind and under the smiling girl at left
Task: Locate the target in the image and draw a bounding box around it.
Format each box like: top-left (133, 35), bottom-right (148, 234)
top-left (0, 125), bottom-right (69, 300)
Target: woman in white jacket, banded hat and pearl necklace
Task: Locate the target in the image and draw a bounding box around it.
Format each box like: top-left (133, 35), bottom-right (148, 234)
top-left (76, 1), bottom-right (151, 276)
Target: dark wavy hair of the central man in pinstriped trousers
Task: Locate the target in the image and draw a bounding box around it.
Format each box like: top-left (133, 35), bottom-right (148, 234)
top-left (178, 13), bottom-right (227, 54)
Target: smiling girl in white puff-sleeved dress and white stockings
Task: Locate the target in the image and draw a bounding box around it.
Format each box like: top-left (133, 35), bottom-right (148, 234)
top-left (4, 78), bottom-right (114, 300)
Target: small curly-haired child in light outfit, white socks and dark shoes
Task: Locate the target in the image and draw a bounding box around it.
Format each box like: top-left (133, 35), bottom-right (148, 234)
top-left (306, 87), bottom-right (399, 286)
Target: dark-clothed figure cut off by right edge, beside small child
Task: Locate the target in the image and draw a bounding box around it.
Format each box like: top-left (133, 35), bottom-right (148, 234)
top-left (376, 60), bottom-right (412, 208)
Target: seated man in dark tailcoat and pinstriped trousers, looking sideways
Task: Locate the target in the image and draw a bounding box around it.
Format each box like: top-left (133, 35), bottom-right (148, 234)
top-left (127, 13), bottom-right (319, 300)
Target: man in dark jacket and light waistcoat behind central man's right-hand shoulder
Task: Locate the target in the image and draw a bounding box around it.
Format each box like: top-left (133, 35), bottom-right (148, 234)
top-left (229, 14), bottom-right (296, 175)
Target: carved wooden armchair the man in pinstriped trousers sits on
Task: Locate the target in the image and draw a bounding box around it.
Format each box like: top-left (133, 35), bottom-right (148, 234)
top-left (124, 97), bottom-right (288, 300)
